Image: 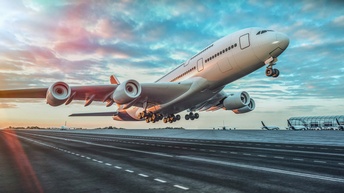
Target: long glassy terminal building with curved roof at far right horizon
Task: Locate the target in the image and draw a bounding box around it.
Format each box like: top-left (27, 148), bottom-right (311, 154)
top-left (289, 115), bottom-right (344, 130)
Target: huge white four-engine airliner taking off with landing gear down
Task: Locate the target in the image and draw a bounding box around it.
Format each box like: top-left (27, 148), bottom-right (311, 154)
top-left (0, 27), bottom-right (289, 123)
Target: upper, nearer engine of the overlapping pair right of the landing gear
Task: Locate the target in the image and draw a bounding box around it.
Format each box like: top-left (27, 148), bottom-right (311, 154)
top-left (223, 91), bottom-right (250, 110)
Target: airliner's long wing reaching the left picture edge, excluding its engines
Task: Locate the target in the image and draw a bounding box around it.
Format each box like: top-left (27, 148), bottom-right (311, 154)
top-left (0, 82), bottom-right (191, 107)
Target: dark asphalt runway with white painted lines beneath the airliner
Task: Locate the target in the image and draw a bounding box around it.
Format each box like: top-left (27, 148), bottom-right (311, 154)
top-left (0, 130), bottom-right (344, 193)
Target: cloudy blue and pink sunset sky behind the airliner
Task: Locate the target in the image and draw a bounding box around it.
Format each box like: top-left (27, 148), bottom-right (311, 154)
top-left (0, 0), bottom-right (344, 129)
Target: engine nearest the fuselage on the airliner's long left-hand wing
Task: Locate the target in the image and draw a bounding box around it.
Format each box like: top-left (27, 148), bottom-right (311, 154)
top-left (112, 80), bottom-right (141, 105)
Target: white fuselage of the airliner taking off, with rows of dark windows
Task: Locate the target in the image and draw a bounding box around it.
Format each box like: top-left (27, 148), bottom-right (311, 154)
top-left (113, 28), bottom-right (289, 120)
